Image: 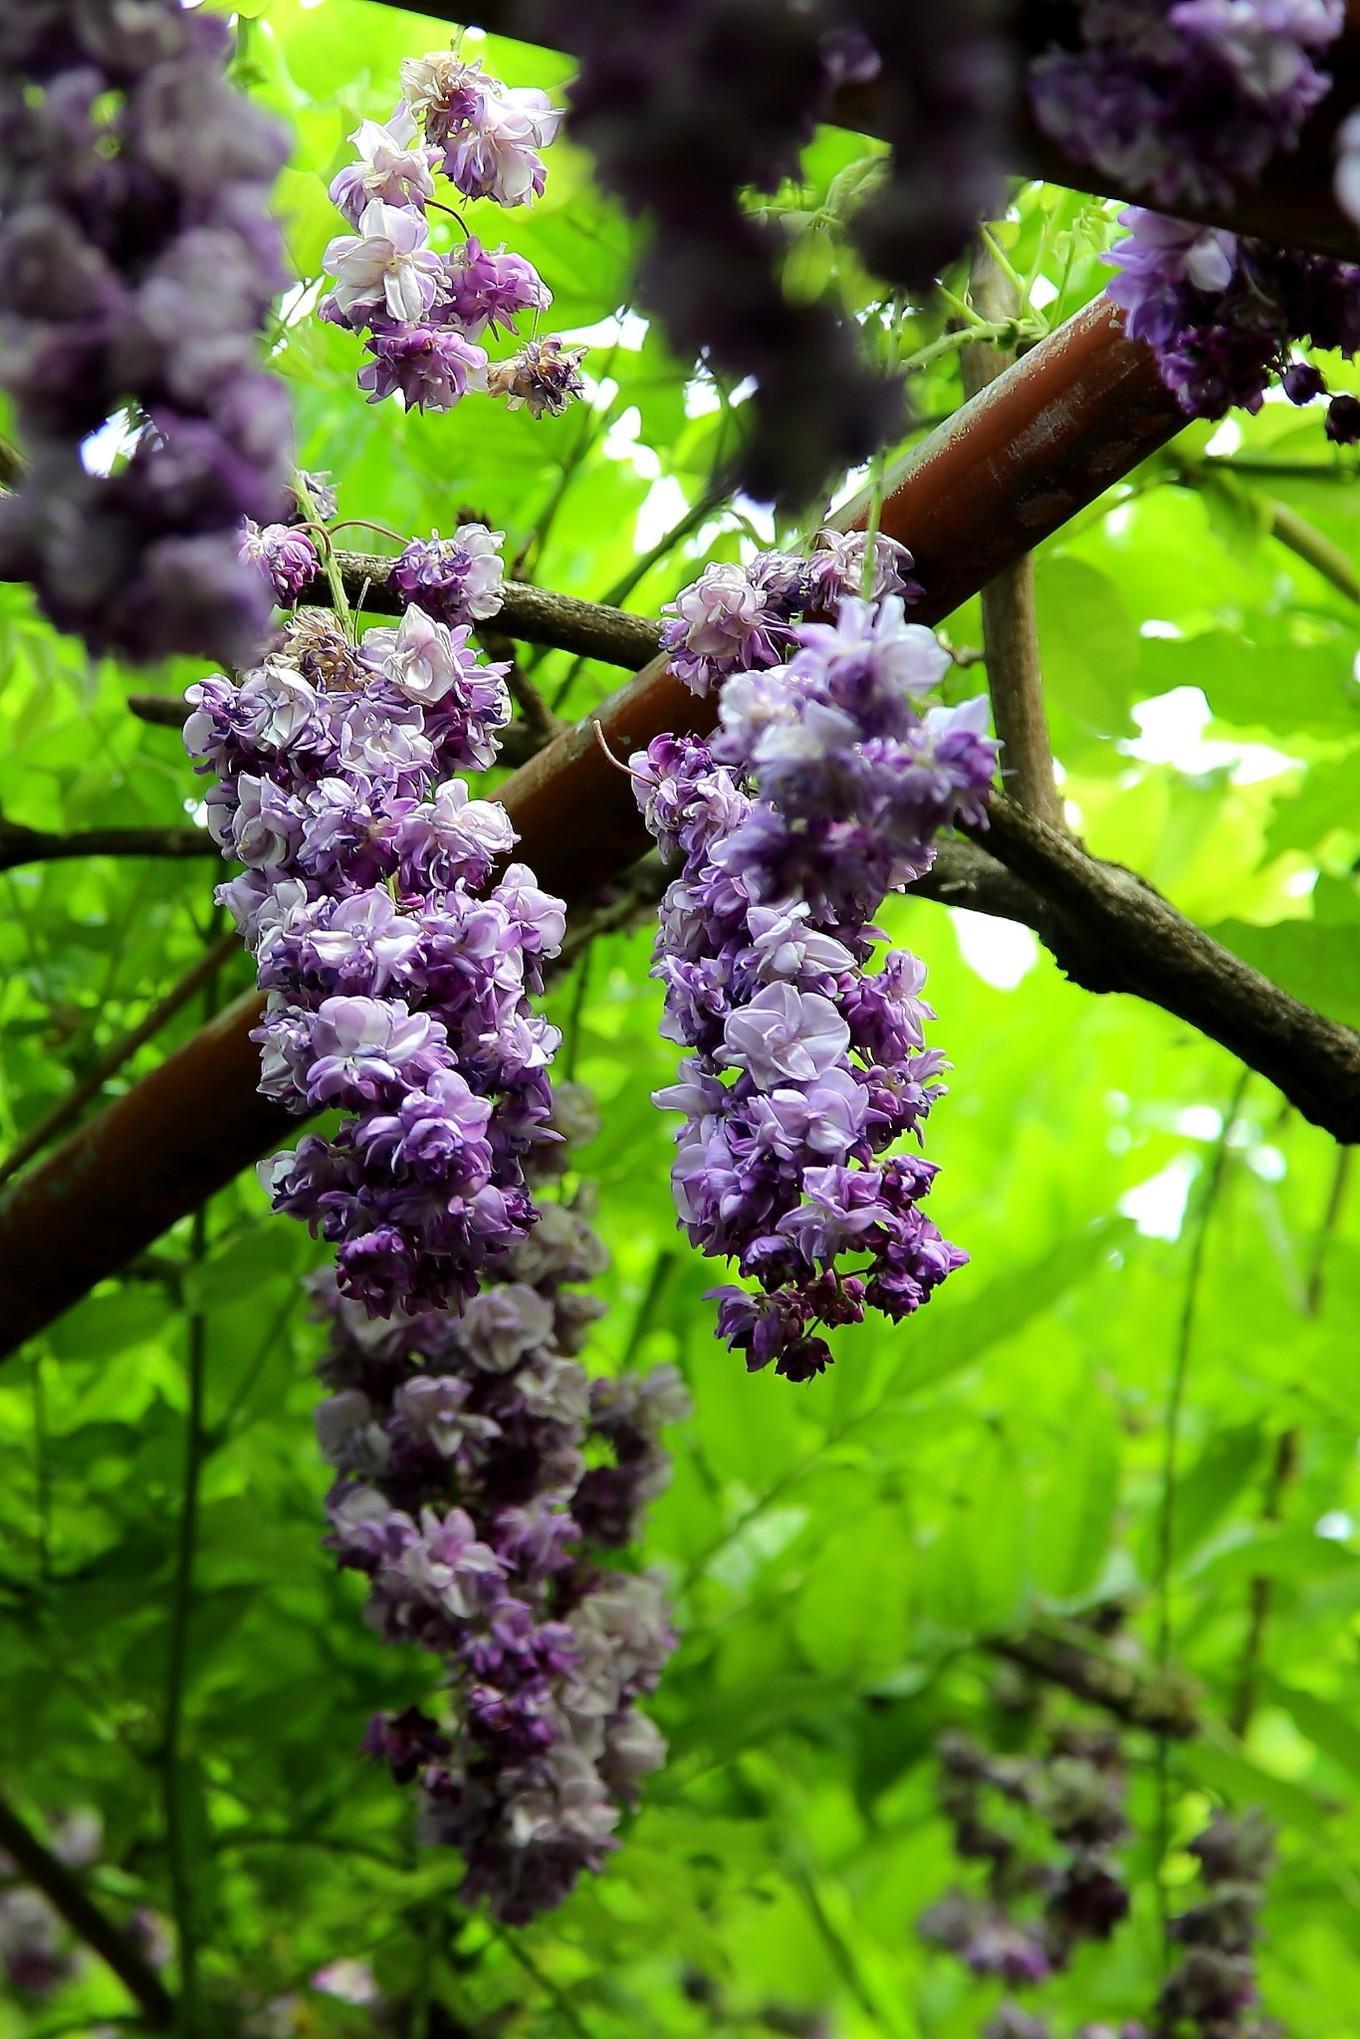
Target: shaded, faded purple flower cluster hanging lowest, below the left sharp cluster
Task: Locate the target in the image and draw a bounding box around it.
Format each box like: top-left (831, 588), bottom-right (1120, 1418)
top-left (318, 1085), bottom-right (687, 1925)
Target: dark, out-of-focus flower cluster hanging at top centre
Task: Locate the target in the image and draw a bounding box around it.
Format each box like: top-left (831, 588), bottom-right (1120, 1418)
top-left (524, 0), bottom-right (901, 500)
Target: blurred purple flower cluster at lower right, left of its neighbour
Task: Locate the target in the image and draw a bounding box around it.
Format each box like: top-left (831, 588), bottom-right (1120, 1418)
top-left (920, 1729), bottom-right (1130, 2006)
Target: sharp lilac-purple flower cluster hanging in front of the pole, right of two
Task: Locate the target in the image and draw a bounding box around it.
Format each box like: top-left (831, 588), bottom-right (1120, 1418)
top-left (630, 540), bottom-right (995, 1380)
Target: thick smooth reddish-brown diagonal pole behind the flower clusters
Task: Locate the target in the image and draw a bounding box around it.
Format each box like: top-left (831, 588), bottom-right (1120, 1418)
top-left (0, 304), bottom-right (1231, 1352)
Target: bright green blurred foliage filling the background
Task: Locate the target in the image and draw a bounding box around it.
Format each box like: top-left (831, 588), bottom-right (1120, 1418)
top-left (0, 0), bottom-right (1360, 2039)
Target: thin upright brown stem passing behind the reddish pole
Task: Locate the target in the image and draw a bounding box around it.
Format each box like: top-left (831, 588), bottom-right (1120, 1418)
top-left (958, 243), bottom-right (1064, 828)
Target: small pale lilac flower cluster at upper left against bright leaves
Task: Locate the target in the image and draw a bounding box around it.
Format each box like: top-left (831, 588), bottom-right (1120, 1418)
top-left (320, 51), bottom-right (585, 418)
